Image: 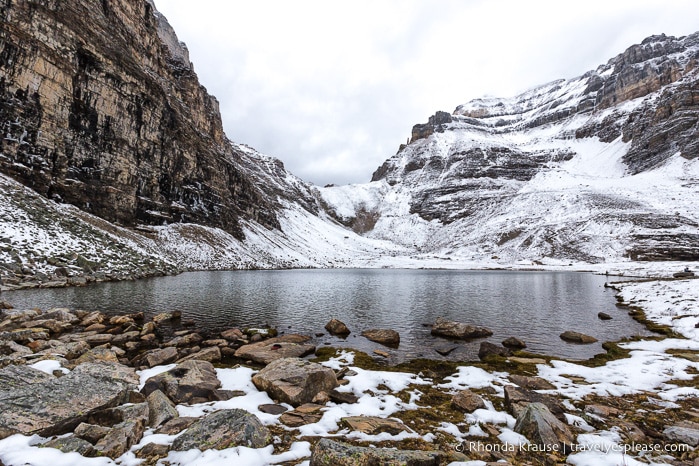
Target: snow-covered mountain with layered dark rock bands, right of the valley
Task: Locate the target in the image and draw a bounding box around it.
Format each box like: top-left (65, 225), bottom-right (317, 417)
top-left (321, 34), bottom-right (699, 263)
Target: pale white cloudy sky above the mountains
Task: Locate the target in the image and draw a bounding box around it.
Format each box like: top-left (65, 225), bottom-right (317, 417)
top-left (155, 0), bottom-right (699, 185)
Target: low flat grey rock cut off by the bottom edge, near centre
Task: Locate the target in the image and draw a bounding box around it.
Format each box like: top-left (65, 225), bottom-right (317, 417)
top-left (310, 438), bottom-right (444, 466)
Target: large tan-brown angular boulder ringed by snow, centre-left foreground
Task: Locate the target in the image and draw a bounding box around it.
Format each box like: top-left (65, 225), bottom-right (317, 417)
top-left (252, 358), bottom-right (339, 406)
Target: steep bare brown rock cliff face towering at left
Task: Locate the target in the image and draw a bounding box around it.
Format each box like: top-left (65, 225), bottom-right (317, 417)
top-left (0, 0), bottom-right (279, 238)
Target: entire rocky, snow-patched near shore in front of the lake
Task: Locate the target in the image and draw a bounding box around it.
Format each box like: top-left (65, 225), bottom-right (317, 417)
top-left (0, 274), bottom-right (699, 466)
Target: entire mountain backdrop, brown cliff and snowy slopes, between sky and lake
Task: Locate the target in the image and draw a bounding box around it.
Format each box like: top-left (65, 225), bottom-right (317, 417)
top-left (0, 0), bottom-right (699, 287)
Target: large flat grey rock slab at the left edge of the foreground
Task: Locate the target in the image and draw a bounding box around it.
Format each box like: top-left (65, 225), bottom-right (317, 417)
top-left (0, 364), bottom-right (137, 437)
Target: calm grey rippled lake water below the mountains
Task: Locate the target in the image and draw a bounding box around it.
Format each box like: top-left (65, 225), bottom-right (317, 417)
top-left (3, 269), bottom-right (648, 362)
